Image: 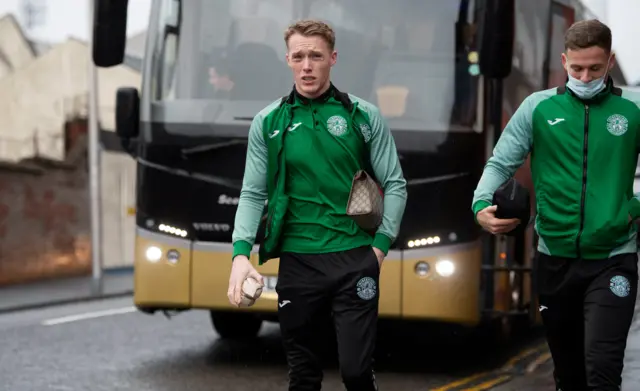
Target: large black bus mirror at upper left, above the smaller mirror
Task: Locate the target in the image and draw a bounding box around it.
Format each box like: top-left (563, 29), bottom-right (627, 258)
top-left (92, 0), bottom-right (128, 67)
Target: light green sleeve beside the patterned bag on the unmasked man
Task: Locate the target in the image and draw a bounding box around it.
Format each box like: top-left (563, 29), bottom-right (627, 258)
top-left (368, 107), bottom-right (407, 254)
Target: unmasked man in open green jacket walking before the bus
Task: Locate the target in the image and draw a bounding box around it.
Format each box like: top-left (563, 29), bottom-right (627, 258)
top-left (228, 20), bottom-right (407, 391)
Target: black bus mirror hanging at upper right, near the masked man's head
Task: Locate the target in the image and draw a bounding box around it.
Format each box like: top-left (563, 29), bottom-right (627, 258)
top-left (478, 0), bottom-right (516, 79)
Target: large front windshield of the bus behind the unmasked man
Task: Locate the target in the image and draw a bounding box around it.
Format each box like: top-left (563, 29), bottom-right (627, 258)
top-left (149, 0), bottom-right (478, 133)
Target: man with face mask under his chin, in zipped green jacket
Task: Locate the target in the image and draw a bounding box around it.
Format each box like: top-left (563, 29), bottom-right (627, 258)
top-left (472, 20), bottom-right (640, 391)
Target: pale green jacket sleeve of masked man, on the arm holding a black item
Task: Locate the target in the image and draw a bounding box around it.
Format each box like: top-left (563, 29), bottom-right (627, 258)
top-left (471, 94), bottom-right (537, 216)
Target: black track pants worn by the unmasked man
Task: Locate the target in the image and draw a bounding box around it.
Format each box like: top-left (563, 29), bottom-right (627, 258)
top-left (276, 246), bottom-right (380, 391)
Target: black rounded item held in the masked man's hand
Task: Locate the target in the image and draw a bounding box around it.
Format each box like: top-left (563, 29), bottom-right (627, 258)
top-left (493, 178), bottom-right (531, 236)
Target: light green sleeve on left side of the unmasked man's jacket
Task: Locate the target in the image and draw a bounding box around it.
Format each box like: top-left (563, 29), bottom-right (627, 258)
top-left (232, 115), bottom-right (267, 259)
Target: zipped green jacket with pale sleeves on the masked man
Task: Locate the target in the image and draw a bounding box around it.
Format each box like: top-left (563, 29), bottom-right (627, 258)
top-left (472, 79), bottom-right (640, 259)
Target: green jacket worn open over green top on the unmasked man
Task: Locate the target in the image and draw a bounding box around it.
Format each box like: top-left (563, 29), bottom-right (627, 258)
top-left (232, 85), bottom-right (407, 264)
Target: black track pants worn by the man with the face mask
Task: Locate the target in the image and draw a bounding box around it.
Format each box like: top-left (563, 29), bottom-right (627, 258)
top-left (536, 253), bottom-right (638, 391)
